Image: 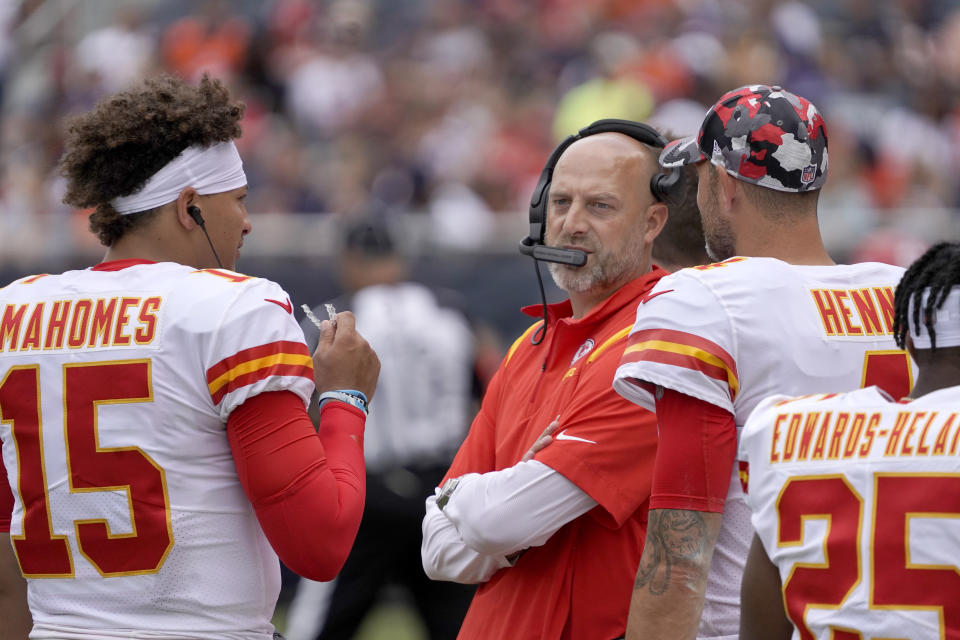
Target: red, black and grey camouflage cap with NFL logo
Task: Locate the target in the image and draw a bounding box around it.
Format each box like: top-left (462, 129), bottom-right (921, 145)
top-left (660, 85), bottom-right (827, 192)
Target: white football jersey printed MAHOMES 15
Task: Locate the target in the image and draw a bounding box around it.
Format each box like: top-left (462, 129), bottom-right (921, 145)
top-left (0, 261), bottom-right (314, 639)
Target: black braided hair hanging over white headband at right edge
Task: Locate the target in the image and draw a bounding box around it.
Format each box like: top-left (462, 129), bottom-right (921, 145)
top-left (893, 242), bottom-right (960, 350)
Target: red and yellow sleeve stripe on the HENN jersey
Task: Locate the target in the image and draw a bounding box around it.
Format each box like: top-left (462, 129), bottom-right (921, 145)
top-left (621, 329), bottom-right (740, 400)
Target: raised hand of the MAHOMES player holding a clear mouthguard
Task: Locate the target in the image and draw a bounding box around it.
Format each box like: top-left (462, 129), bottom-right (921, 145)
top-left (313, 311), bottom-right (380, 401)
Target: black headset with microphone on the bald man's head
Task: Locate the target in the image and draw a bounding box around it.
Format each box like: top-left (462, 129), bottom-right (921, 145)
top-left (520, 118), bottom-right (682, 267)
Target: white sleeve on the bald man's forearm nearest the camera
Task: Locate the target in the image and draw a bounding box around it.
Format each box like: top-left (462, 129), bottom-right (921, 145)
top-left (442, 460), bottom-right (597, 557)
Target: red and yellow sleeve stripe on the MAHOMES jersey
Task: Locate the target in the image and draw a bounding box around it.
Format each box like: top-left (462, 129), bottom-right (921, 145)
top-left (207, 340), bottom-right (313, 404)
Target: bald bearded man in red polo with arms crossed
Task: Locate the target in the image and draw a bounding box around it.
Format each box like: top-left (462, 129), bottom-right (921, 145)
top-left (421, 133), bottom-right (702, 640)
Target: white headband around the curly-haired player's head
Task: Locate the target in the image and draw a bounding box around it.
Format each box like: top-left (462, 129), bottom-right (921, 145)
top-left (110, 142), bottom-right (247, 215)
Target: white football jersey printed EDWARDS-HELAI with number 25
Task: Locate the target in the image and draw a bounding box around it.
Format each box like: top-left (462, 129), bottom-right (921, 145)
top-left (740, 387), bottom-right (960, 640)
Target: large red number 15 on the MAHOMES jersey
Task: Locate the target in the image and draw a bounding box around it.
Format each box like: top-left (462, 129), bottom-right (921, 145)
top-left (0, 360), bottom-right (173, 578)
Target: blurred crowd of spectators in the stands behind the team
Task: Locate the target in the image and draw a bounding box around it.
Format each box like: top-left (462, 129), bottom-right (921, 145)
top-left (0, 0), bottom-right (960, 264)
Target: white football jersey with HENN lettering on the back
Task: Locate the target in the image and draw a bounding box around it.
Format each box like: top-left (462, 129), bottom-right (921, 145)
top-left (614, 257), bottom-right (913, 638)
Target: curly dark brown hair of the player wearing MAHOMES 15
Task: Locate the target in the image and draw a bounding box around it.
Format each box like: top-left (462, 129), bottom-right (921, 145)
top-left (60, 75), bottom-right (244, 247)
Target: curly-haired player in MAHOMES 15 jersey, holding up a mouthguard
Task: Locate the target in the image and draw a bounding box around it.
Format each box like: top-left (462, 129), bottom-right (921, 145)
top-left (0, 77), bottom-right (379, 639)
